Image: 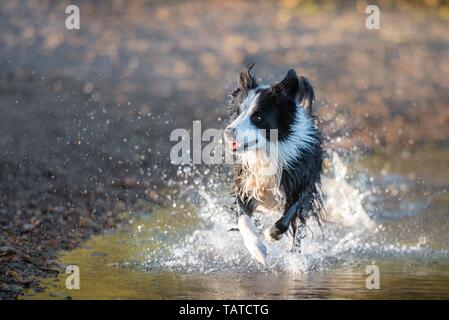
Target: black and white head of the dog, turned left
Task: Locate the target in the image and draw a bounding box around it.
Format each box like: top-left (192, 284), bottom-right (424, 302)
top-left (225, 64), bottom-right (314, 153)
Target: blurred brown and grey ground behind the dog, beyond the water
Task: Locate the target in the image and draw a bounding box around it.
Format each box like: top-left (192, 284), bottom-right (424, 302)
top-left (0, 0), bottom-right (449, 296)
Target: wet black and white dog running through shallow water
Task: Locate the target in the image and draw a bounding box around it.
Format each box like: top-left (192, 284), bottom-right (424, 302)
top-left (225, 64), bottom-right (324, 264)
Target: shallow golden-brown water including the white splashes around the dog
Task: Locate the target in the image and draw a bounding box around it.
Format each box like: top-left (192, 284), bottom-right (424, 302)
top-left (24, 148), bottom-right (449, 299)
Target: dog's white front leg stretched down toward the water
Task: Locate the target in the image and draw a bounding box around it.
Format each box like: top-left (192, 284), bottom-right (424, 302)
top-left (237, 199), bottom-right (267, 265)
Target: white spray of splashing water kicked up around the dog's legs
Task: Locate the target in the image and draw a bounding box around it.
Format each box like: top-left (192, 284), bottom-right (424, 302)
top-left (145, 153), bottom-right (447, 274)
